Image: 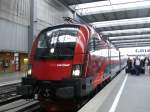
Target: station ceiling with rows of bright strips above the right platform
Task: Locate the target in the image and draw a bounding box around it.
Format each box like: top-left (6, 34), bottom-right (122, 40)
top-left (59, 0), bottom-right (150, 48)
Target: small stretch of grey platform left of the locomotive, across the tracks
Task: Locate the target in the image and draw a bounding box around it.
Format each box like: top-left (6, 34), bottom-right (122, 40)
top-left (0, 72), bottom-right (25, 84)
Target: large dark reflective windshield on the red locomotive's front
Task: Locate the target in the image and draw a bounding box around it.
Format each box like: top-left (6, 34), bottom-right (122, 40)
top-left (36, 28), bottom-right (79, 59)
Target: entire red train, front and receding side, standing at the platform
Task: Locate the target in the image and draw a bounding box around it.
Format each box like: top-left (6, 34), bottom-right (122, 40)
top-left (18, 24), bottom-right (120, 100)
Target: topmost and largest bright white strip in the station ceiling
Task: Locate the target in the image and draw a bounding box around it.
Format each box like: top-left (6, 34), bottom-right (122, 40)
top-left (70, 0), bottom-right (150, 16)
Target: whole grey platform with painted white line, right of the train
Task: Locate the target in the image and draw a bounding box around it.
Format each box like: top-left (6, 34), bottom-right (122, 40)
top-left (78, 71), bottom-right (150, 112)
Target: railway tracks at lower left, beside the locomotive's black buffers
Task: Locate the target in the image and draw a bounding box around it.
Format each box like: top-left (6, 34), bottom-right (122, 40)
top-left (0, 80), bottom-right (40, 112)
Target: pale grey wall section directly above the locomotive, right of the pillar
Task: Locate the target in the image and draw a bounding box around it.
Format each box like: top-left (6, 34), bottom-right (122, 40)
top-left (35, 0), bottom-right (73, 34)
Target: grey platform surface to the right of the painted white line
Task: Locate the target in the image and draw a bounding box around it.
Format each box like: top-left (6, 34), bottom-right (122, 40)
top-left (116, 75), bottom-right (150, 112)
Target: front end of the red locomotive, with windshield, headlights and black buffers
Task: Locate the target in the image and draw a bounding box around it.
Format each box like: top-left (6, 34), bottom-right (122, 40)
top-left (18, 25), bottom-right (92, 99)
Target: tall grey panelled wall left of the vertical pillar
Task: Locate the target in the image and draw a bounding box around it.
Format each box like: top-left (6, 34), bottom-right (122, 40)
top-left (0, 0), bottom-right (30, 52)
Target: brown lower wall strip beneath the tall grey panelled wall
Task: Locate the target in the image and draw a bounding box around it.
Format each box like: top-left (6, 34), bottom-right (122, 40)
top-left (0, 52), bottom-right (28, 73)
